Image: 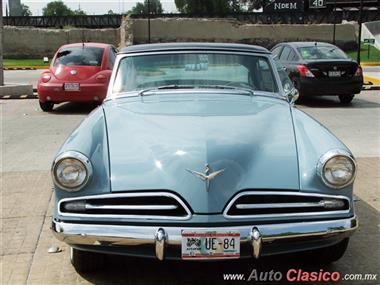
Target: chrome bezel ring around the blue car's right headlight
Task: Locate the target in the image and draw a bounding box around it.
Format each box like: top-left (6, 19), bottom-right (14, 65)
top-left (317, 149), bottom-right (357, 189)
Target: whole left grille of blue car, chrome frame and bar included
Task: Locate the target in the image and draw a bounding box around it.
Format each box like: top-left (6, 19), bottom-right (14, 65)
top-left (58, 192), bottom-right (191, 220)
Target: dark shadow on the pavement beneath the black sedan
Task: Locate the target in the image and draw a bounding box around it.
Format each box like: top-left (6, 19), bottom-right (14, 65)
top-left (296, 94), bottom-right (380, 109)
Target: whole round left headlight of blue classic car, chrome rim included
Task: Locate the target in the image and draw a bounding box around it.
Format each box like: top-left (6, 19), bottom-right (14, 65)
top-left (52, 151), bottom-right (92, 191)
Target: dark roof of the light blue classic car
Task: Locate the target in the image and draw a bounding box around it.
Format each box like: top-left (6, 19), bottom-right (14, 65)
top-left (120, 43), bottom-right (269, 54)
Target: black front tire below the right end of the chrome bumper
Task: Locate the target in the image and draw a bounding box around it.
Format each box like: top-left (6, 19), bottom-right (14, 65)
top-left (304, 238), bottom-right (350, 264)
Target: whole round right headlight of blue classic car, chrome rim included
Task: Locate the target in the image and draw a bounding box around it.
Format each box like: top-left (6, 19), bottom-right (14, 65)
top-left (317, 150), bottom-right (356, 189)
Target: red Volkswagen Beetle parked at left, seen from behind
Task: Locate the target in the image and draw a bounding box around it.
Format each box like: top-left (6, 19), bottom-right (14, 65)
top-left (38, 43), bottom-right (117, 111)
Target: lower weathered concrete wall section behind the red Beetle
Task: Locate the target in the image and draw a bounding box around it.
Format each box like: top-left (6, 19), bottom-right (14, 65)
top-left (3, 26), bottom-right (120, 58)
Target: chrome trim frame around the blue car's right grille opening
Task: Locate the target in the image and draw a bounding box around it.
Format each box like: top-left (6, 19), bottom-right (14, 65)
top-left (223, 191), bottom-right (351, 219)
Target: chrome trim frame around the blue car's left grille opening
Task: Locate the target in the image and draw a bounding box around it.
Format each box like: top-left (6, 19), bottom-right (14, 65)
top-left (57, 191), bottom-right (192, 220)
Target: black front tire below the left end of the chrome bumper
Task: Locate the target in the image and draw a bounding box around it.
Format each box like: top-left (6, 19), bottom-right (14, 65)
top-left (70, 247), bottom-right (106, 273)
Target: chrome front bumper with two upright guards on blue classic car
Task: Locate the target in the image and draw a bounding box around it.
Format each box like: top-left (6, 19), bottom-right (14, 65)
top-left (52, 216), bottom-right (358, 260)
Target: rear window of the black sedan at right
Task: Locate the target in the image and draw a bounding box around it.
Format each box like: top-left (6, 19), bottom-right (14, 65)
top-left (298, 46), bottom-right (347, 60)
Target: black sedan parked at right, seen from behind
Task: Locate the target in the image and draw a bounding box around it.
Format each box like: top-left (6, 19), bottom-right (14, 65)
top-left (272, 42), bottom-right (363, 103)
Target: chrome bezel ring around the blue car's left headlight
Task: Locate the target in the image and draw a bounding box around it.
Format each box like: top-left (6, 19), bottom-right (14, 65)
top-left (51, 151), bottom-right (93, 192)
